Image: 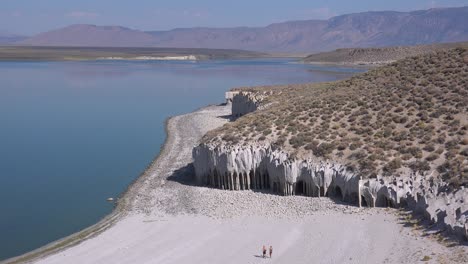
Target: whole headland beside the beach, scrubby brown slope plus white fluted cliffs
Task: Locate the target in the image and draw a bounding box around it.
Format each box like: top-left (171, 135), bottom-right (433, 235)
top-left (193, 48), bottom-right (468, 238)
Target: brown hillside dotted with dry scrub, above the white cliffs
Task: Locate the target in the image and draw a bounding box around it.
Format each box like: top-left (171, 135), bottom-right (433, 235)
top-left (204, 48), bottom-right (468, 187)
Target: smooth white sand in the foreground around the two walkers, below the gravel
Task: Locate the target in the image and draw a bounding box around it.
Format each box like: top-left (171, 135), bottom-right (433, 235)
top-left (39, 213), bottom-right (460, 263)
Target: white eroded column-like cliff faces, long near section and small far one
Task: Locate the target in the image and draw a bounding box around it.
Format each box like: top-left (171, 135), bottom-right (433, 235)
top-left (193, 78), bottom-right (468, 238)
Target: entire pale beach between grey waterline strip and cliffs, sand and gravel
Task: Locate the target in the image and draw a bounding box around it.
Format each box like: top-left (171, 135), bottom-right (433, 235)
top-left (12, 106), bottom-right (468, 263)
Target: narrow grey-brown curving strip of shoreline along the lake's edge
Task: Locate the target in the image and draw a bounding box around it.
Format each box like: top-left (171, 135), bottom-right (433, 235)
top-left (0, 105), bottom-right (212, 264)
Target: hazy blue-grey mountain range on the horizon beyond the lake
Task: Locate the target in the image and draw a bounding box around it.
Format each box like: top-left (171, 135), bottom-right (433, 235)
top-left (5, 7), bottom-right (468, 53)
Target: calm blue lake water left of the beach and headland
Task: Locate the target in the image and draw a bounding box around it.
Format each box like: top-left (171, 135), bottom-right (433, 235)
top-left (0, 59), bottom-right (362, 260)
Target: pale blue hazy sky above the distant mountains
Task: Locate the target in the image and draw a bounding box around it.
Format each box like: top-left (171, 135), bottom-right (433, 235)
top-left (0, 0), bottom-right (468, 35)
